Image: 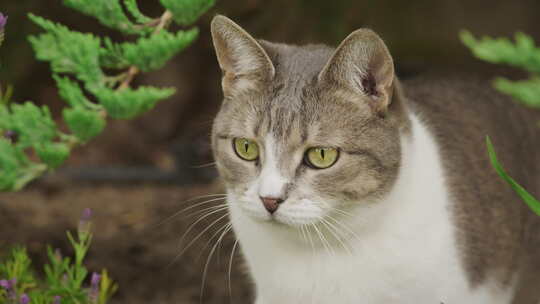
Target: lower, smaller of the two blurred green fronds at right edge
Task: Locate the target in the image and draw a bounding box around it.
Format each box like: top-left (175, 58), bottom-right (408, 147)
top-left (494, 77), bottom-right (540, 108)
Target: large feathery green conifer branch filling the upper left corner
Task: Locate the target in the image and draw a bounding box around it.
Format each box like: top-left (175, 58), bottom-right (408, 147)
top-left (0, 0), bottom-right (215, 191)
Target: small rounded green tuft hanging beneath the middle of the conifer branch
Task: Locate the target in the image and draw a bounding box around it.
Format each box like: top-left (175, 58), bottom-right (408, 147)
top-left (62, 108), bottom-right (106, 143)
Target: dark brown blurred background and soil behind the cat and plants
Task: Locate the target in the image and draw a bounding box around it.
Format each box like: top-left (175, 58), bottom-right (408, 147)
top-left (0, 0), bottom-right (540, 303)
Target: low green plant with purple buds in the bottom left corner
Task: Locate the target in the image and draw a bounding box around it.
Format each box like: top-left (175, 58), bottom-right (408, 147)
top-left (0, 209), bottom-right (117, 304)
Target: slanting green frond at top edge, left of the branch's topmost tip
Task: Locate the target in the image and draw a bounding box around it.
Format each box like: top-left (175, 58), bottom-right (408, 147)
top-left (64, 0), bottom-right (141, 34)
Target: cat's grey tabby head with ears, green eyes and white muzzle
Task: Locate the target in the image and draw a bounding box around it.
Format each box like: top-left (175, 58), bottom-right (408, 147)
top-left (212, 16), bottom-right (407, 226)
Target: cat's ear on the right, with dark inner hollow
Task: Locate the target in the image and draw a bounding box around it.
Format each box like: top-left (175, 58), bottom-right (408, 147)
top-left (319, 29), bottom-right (394, 116)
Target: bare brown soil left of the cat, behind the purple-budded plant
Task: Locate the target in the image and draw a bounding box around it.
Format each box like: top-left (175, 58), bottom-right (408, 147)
top-left (0, 184), bottom-right (252, 304)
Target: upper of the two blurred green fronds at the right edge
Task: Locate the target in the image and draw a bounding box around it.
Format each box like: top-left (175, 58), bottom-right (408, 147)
top-left (460, 31), bottom-right (540, 73)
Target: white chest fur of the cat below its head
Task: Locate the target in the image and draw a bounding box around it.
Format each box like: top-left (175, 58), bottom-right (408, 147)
top-left (230, 117), bottom-right (512, 304)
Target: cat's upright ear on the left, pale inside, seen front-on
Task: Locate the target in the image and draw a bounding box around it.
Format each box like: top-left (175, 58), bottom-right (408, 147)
top-left (211, 15), bottom-right (275, 91)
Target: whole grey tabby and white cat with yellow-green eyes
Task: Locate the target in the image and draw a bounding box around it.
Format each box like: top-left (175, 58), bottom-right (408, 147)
top-left (211, 15), bottom-right (540, 304)
